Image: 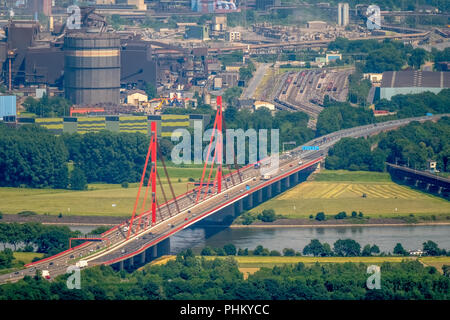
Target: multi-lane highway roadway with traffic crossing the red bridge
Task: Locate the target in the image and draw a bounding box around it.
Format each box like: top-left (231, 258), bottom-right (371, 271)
top-left (0, 114), bottom-right (450, 283)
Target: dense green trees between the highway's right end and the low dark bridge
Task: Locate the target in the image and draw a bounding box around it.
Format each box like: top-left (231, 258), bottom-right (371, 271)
top-left (325, 117), bottom-right (450, 171)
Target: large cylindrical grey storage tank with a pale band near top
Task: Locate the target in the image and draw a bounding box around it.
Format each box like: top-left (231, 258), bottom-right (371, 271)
top-left (64, 33), bottom-right (120, 105)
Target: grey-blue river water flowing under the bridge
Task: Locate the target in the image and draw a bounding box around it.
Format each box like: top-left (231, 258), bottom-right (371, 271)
top-left (70, 225), bottom-right (450, 254)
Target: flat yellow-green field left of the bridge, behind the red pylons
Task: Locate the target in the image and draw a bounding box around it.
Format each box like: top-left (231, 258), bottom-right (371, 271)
top-left (0, 168), bottom-right (209, 216)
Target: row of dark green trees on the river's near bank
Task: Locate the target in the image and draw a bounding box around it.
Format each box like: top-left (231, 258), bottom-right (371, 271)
top-left (200, 239), bottom-right (450, 257)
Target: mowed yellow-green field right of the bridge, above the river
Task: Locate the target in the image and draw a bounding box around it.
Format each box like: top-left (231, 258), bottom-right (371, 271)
top-left (251, 170), bottom-right (450, 218)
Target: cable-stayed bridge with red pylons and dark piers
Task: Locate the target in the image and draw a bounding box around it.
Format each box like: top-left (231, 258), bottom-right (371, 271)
top-left (0, 104), bottom-right (448, 283)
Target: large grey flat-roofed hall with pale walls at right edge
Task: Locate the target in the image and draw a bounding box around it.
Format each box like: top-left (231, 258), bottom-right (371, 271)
top-left (378, 71), bottom-right (450, 100)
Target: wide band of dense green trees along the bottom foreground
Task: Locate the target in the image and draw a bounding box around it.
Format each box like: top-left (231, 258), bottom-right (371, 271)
top-left (0, 250), bottom-right (450, 300)
